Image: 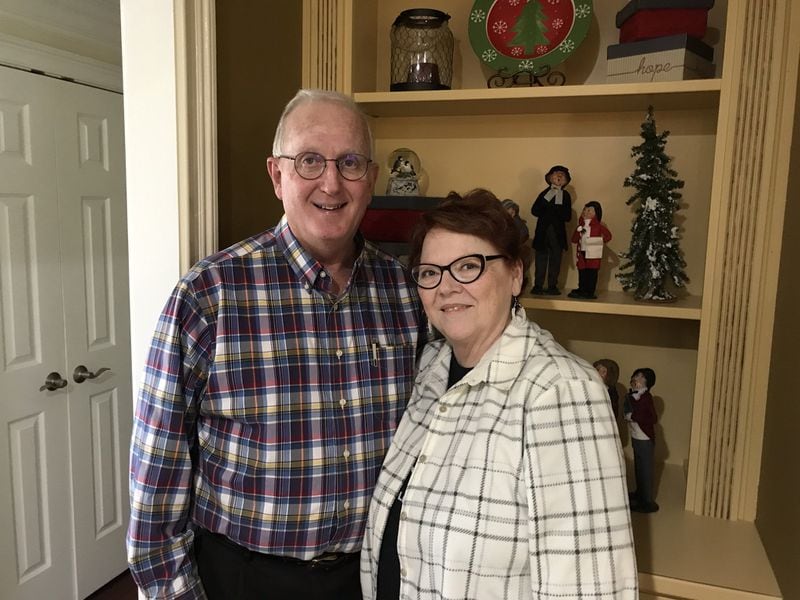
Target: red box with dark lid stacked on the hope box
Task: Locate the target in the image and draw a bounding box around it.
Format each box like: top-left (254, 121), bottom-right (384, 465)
top-left (616, 0), bottom-right (714, 44)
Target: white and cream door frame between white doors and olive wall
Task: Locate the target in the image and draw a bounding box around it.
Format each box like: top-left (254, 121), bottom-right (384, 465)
top-left (119, 0), bottom-right (217, 400)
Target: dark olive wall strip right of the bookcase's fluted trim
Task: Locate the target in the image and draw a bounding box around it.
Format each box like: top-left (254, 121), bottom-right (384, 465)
top-left (756, 67), bottom-right (800, 600)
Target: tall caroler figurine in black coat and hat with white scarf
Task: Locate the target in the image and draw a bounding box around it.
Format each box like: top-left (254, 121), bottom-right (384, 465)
top-left (531, 165), bottom-right (572, 296)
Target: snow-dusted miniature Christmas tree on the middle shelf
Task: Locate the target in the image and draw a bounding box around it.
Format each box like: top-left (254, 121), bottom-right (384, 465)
top-left (617, 106), bottom-right (689, 302)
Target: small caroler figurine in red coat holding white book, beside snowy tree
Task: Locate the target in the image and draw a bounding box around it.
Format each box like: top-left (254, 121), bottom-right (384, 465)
top-left (567, 200), bottom-right (611, 300)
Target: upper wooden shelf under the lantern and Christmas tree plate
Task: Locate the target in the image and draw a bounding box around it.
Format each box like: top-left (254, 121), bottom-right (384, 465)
top-left (353, 79), bottom-right (721, 117)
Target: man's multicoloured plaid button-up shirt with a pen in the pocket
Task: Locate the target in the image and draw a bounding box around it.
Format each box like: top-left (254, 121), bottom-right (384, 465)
top-left (128, 218), bottom-right (420, 598)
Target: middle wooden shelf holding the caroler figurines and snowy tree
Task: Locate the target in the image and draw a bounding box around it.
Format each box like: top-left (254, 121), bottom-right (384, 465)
top-left (519, 291), bottom-right (702, 321)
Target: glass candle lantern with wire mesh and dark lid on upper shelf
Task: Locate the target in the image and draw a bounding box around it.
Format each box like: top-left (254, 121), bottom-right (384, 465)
top-left (390, 8), bottom-right (453, 91)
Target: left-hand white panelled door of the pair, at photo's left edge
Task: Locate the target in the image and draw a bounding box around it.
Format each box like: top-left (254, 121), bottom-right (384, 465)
top-left (0, 67), bottom-right (74, 600)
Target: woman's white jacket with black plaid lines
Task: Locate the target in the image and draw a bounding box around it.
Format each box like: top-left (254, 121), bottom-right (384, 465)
top-left (361, 311), bottom-right (638, 600)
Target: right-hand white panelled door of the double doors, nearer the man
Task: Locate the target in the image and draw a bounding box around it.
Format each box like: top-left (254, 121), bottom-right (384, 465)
top-left (56, 76), bottom-right (133, 597)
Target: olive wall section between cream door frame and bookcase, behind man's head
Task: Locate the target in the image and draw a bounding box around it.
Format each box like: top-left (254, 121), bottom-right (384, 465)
top-left (216, 0), bottom-right (302, 248)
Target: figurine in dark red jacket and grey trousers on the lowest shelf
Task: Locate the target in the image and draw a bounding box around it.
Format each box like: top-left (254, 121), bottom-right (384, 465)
top-left (623, 368), bottom-right (658, 512)
